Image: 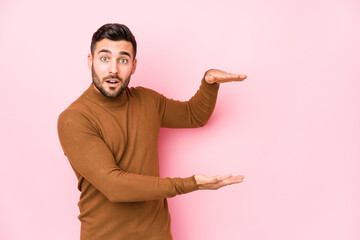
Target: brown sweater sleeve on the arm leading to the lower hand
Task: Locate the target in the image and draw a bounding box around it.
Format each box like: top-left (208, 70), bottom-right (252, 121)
top-left (58, 110), bottom-right (198, 202)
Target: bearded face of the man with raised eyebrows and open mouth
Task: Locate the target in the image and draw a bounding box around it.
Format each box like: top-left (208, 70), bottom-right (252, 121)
top-left (88, 38), bottom-right (137, 97)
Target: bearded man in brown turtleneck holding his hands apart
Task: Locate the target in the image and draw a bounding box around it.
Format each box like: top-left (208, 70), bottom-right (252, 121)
top-left (58, 24), bottom-right (246, 240)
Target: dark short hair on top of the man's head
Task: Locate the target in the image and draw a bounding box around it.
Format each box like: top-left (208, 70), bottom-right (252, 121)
top-left (90, 23), bottom-right (136, 58)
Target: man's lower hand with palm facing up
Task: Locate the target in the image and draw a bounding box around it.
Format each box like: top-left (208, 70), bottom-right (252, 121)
top-left (195, 174), bottom-right (244, 190)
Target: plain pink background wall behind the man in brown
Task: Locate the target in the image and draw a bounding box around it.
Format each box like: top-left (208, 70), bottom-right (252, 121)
top-left (0, 0), bottom-right (360, 240)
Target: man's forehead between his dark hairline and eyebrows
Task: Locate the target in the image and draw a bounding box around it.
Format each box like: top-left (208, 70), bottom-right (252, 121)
top-left (94, 38), bottom-right (133, 57)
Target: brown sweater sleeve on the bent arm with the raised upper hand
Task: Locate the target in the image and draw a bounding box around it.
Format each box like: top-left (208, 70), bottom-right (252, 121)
top-left (160, 79), bottom-right (219, 128)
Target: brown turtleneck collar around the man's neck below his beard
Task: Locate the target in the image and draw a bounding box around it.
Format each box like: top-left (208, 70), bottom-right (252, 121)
top-left (85, 83), bottom-right (129, 107)
